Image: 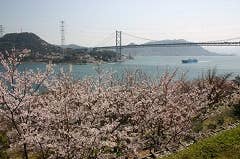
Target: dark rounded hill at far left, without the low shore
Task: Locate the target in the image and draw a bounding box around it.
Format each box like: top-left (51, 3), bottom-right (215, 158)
top-left (0, 32), bottom-right (62, 54)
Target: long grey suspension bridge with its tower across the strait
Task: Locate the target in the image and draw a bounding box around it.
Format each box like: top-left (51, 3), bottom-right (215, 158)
top-left (93, 31), bottom-right (240, 58)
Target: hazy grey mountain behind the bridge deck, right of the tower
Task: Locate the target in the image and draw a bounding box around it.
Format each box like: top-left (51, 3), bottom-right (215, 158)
top-left (122, 39), bottom-right (219, 56)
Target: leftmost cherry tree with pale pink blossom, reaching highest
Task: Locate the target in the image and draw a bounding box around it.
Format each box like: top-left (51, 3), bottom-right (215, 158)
top-left (0, 52), bottom-right (50, 158)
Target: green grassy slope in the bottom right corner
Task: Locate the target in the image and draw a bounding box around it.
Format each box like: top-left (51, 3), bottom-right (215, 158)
top-left (161, 126), bottom-right (240, 159)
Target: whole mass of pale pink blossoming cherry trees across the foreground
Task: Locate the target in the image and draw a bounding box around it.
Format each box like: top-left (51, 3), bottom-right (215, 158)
top-left (0, 51), bottom-right (234, 159)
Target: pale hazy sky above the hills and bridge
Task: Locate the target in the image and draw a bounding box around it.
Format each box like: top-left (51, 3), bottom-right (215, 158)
top-left (0, 0), bottom-right (240, 46)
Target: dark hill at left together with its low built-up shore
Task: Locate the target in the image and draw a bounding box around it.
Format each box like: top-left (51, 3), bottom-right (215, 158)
top-left (0, 32), bottom-right (116, 63)
